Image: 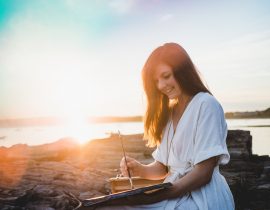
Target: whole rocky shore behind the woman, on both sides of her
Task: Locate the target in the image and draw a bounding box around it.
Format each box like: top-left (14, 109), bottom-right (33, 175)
top-left (0, 130), bottom-right (270, 210)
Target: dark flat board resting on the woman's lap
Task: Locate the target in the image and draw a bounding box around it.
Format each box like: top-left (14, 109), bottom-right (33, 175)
top-left (82, 182), bottom-right (172, 207)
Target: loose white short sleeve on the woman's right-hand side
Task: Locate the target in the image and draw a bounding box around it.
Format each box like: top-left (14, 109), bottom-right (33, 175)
top-left (194, 96), bottom-right (230, 165)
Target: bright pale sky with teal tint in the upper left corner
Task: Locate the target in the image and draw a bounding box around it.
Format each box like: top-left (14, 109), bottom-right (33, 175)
top-left (0, 0), bottom-right (270, 118)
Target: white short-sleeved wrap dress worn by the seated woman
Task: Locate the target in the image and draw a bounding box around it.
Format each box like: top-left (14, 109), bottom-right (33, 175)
top-left (98, 92), bottom-right (235, 210)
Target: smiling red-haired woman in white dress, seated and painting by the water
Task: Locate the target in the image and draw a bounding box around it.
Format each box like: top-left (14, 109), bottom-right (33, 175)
top-left (100, 43), bottom-right (234, 210)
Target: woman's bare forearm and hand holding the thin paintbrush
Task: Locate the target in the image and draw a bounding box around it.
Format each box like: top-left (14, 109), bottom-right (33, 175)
top-left (120, 157), bottom-right (167, 180)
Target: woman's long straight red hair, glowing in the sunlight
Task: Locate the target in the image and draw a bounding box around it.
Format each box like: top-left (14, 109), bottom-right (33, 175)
top-left (142, 43), bottom-right (211, 147)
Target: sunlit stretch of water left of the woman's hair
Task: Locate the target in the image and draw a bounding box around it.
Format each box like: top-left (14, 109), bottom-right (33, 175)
top-left (0, 122), bottom-right (143, 147)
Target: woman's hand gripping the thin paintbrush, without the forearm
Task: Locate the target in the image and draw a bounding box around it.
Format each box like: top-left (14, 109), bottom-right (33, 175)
top-left (120, 156), bottom-right (143, 177)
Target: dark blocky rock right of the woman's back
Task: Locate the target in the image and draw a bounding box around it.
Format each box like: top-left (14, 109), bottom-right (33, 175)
top-left (221, 130), bottom-right (270, 210)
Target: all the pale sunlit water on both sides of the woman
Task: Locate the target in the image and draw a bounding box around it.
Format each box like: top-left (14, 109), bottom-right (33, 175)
top-left (0, 119), bottom-right (270, 155)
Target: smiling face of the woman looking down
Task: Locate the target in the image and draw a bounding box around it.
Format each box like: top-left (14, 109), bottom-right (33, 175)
top-left (154, 64), bottom-right (182, 99)
